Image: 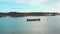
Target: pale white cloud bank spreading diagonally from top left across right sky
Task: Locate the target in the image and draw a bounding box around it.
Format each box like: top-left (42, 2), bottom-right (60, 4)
top-left (0, 0), bottom-right (60, 11)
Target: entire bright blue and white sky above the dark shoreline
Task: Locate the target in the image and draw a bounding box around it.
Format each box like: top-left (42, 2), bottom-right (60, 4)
top-left (0, 0), bottom-right (60, 12)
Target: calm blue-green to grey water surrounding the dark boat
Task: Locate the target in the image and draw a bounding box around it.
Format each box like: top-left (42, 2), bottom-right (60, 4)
top-left (0, 16), bottom-right (60, 34)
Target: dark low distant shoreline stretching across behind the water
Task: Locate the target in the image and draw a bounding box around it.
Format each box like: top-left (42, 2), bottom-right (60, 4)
top-left (0, 12), bottom-right (60, 17)
